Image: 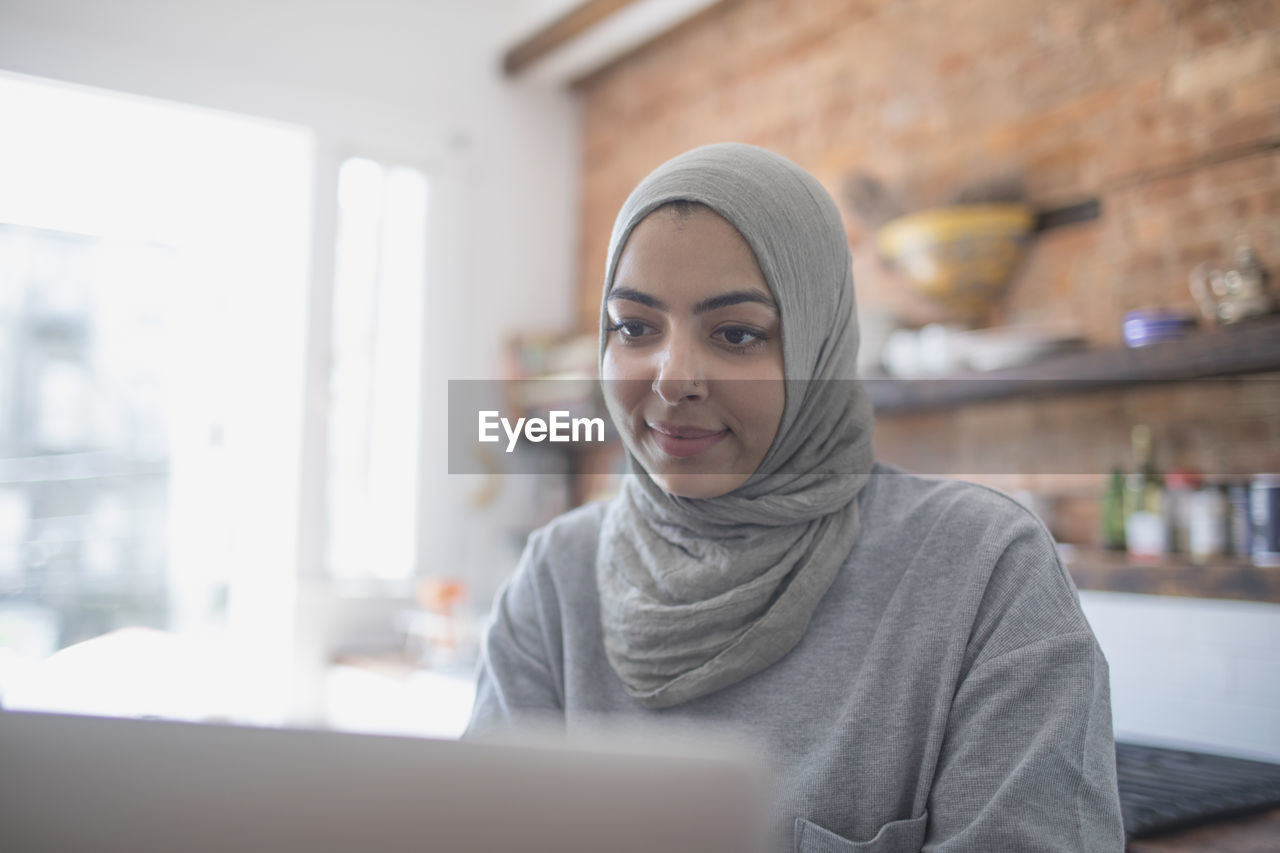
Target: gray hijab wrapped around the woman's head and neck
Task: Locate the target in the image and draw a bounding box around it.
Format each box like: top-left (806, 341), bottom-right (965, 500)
top-left (596, 143), bottom-right (873, 708)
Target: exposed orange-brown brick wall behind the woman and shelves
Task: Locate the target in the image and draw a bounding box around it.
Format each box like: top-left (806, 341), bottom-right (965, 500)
top-left (579, 0), bottom-right (1280, 545)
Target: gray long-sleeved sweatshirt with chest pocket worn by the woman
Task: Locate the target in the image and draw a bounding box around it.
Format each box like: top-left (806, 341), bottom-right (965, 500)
top-left (468, 466), bottom-right (1124, 853)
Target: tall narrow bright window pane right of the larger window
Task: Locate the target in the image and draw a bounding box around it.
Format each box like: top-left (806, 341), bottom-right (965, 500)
top-left (325, 159), bottom-right (428, 580)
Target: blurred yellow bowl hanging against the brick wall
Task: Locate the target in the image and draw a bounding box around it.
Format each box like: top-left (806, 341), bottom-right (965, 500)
top-left (876, 204), bottom-right (1036, 324)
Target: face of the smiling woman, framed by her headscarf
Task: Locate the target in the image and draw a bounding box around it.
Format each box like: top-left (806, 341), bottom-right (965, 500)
top-left (602, 205), bottom-right (786, 498)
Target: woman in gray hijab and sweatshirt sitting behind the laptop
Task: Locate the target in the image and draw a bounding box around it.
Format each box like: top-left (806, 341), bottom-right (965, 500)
top-left (470, 143), bottom-right (1123, 853)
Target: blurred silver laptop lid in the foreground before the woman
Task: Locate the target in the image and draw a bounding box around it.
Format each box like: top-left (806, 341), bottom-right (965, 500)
top-left (0, 711), bottom-right (765, 853)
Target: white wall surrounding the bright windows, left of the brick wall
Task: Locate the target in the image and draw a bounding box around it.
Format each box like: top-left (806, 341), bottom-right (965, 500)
top-left (0, 0), bottom-right (580, 717)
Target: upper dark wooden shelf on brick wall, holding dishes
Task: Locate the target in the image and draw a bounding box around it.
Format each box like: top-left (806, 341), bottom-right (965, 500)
top-left (864, 316), bottom-right (1280, 415)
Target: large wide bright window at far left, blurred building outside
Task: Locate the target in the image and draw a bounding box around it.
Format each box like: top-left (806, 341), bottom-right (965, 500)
top-left (0, 76), bottom-right (314, 721)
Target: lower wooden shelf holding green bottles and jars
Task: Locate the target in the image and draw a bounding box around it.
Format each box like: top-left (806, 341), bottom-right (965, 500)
top-left (1065, 547), bottom-right (1280, 603)
